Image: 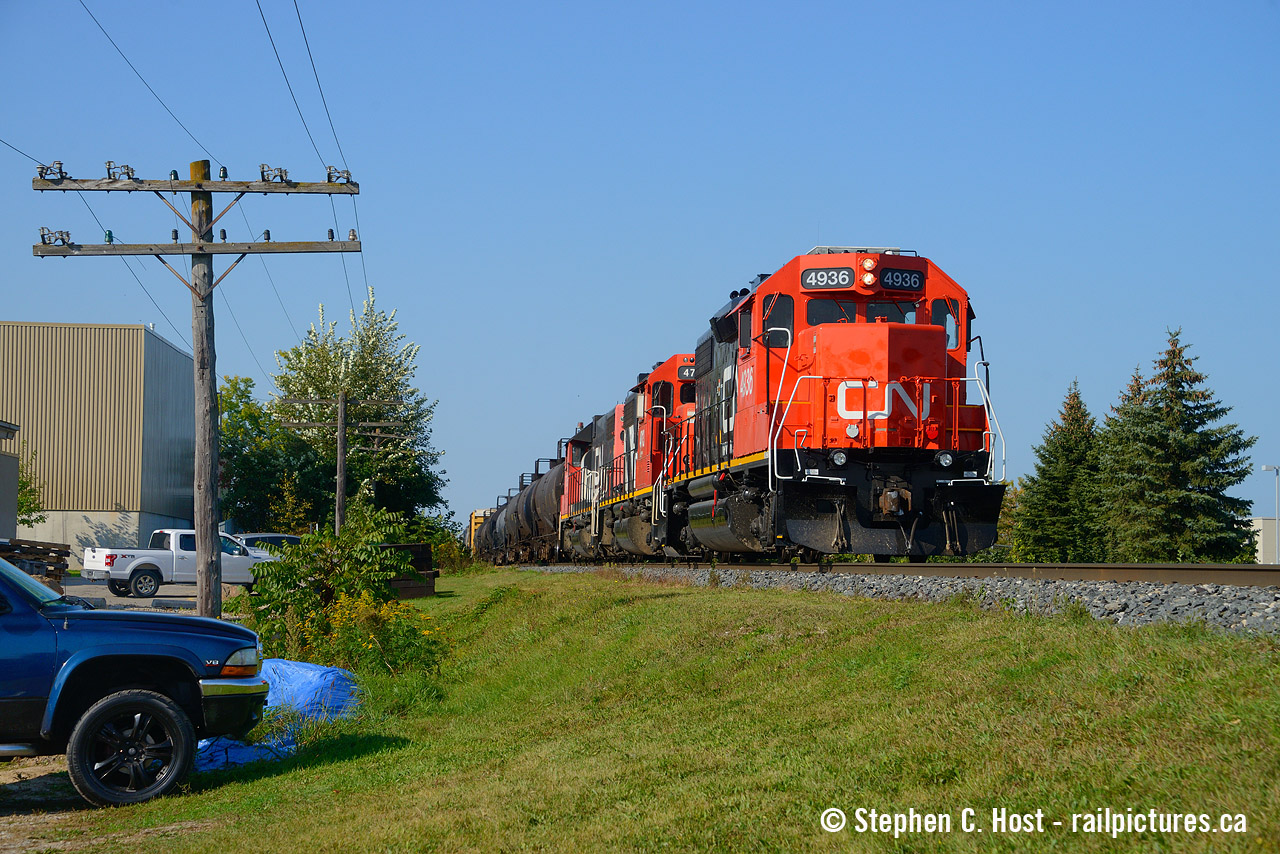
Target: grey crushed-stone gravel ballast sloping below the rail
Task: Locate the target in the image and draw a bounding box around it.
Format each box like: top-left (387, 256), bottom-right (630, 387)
top-left (530, 565), bottom-right (1280, 634)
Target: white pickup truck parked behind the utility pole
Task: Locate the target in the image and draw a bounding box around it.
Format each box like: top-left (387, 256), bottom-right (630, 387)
top-left (81, 529), bottom-right (274, 598)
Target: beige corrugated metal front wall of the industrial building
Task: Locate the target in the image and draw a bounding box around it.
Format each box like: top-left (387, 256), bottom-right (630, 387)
top-left (0, 321), bottom-right (147, 511)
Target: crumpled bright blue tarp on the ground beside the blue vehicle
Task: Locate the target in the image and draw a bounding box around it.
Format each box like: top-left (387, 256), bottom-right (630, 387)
top-left (196, 658), bottom-right (360, 771)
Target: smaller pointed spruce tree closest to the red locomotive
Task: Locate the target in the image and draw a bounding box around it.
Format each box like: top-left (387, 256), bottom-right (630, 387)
top-left (1014, 382), bottom-right (1105, 563)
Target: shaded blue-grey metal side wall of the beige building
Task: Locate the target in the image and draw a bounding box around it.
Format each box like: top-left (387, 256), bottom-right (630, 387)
top-left (142, 329), bottom-right (196, 519)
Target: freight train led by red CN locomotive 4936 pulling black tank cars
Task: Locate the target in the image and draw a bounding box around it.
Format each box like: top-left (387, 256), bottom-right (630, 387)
top-left (475, 246), bottom-right (1005, 562)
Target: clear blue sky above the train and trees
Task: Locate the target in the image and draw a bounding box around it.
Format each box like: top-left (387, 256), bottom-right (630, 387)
top-left (0, 0), bottom-right (1280, 527)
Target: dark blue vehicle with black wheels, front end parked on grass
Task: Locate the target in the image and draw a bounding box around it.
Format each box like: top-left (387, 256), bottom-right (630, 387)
top-left (0, 560), bottom-right (268, 805)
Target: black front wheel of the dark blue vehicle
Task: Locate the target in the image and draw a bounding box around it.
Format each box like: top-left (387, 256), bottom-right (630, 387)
top-left (67, 690), bottom-right (196, 807)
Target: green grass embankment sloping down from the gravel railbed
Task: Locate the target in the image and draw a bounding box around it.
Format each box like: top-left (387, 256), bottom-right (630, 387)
top-left (20, 571), bottom-right (1280, 853)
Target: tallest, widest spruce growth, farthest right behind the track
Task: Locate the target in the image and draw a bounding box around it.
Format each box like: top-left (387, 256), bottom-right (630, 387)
top-left (1101, 329), bottom-right (1257, 562)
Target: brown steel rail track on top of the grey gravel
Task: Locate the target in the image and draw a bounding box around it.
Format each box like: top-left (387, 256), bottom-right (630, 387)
top-left (535, 562), bottom-right (1280, 588)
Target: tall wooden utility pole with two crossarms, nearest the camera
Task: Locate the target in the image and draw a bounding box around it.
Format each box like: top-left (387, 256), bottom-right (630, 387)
top-left (31, 160), bottom-right (361, 617)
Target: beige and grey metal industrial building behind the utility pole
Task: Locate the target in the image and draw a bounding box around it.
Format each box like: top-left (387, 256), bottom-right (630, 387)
top-left (0, 321), bottom-right (196, 566)
